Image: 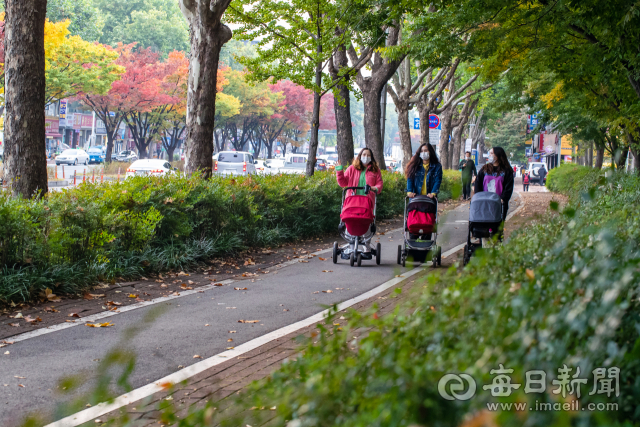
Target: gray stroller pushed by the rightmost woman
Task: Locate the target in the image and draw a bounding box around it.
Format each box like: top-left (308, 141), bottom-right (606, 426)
top-left (463, 191), bottom-right (503, 265)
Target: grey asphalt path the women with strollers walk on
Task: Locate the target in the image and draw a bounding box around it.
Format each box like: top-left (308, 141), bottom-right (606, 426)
top-left (0, 203), bottom-right (468, 426)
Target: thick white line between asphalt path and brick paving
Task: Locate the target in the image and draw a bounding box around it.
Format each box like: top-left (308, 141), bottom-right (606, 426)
top-left (45, 266), bottom-right (427, 427)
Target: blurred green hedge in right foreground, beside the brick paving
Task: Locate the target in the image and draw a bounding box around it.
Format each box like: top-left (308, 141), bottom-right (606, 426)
top-left (182, 169), bottom-right (640, 427)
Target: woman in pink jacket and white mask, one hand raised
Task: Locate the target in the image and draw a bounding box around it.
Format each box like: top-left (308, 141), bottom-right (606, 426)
top-left (336, 148), bottom-right (382, 202)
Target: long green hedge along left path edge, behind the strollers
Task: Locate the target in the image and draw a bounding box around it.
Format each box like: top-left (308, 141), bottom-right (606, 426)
top-left (0, 172), bottom-right (460, 303)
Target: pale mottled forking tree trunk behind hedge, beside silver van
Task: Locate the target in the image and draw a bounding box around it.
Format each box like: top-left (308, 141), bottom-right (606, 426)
top-left (181, 0), bottom-right (231, 177)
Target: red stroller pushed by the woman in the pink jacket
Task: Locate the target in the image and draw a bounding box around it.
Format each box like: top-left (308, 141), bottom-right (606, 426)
top-left (333, 185), bottom-right (381, 267)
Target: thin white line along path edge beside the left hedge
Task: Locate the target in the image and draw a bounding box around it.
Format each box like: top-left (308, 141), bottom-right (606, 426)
top-left (7, 228), bottom-right (402, 343)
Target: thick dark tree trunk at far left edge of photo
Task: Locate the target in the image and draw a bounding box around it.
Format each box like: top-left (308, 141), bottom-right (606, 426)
top-left (4, 0), bottom-right (48, 197)
